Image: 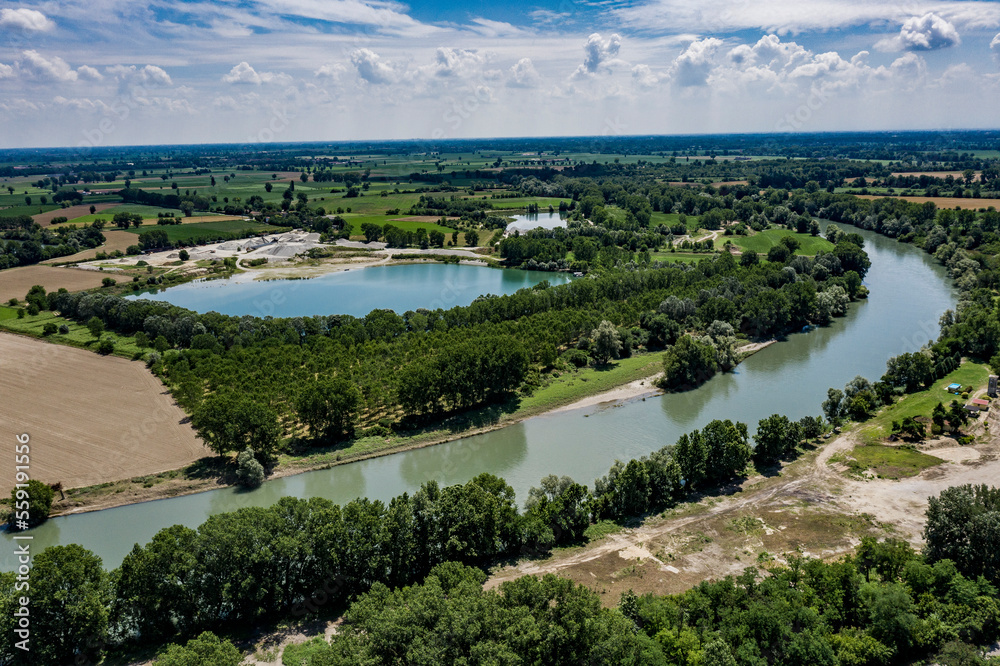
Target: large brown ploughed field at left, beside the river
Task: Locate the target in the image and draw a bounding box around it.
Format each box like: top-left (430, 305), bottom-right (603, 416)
top-left (0, 332), bottom-right (211, 495)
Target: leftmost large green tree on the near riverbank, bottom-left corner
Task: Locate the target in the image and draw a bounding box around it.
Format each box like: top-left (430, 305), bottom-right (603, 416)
top-left (27, 544), bottom-right (110, 665)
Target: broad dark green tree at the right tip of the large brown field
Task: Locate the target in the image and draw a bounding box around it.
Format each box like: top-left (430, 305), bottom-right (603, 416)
top-left (191, 393), bottom-right (281, 458)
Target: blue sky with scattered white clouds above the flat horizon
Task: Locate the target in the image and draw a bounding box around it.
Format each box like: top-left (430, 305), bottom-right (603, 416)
top-left (0, 0), bottom-right (1000, 148)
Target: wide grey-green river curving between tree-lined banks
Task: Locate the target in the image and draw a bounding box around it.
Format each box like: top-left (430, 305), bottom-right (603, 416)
top-left (0, 229), bottom-right (955, 570)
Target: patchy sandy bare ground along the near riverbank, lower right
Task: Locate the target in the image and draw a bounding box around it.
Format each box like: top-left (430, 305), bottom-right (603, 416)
top-left (487, 422), bottom-right (1000, 606)
